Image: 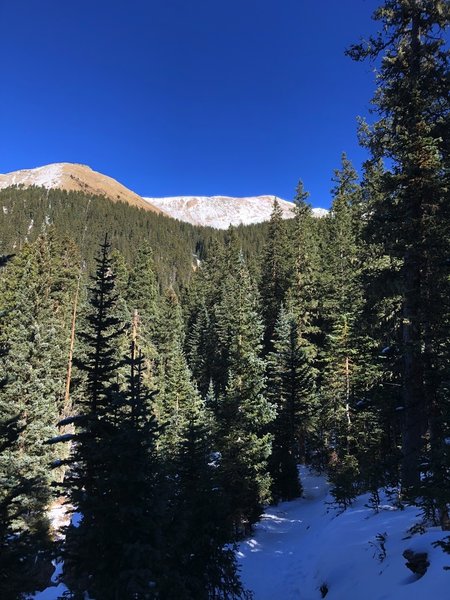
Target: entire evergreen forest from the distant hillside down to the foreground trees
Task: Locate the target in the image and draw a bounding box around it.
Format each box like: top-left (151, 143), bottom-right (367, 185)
top-left (0, 0), bottom-right (450, 600)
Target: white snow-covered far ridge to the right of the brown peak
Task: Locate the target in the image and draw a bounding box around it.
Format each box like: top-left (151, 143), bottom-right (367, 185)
top-left (144, 196), bottom-right (327, 229)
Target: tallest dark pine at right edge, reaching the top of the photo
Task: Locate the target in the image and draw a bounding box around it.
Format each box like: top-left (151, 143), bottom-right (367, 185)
top-left (348, 0), bottom-right (450, 506)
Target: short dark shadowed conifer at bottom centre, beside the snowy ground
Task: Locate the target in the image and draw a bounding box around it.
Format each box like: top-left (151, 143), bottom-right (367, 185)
top-left (162, 408), bottom-right (248, 600)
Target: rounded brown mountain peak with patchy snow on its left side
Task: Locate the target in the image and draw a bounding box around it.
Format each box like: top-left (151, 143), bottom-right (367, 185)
top-left (0, 163), bottom-right (163, 213)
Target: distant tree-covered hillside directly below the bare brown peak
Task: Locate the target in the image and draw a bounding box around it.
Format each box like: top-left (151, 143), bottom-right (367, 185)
top-left (0, 187), bottom-right (274, 289)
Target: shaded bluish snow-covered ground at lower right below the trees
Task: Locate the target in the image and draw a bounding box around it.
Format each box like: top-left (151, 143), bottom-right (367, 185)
top-left (238, 468), bottom-right (450, 600)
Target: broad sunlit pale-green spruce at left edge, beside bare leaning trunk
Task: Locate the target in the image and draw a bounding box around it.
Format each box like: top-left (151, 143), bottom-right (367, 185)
top-left (0, 235), bottom-right (75, 528)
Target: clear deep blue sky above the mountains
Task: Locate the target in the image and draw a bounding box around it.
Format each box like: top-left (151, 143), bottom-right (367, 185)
top-left (0, 0), bottom-right (380, 206)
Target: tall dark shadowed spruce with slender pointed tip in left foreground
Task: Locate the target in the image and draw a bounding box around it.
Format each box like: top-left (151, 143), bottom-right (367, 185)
top-left (60, 238), bottom-right (125, 598)
